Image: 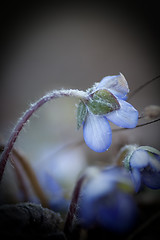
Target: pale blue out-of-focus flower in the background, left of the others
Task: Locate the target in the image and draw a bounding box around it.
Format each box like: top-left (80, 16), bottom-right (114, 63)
top-left (34, 145), bottom-right (87, 213)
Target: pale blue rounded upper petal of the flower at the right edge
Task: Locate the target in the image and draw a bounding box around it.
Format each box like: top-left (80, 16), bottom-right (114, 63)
top-left (130, 150), bottom-right (149, 168)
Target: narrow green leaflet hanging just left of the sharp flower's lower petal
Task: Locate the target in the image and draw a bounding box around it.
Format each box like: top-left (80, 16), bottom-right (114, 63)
top-left (77, 101), bottom-right (87, 129)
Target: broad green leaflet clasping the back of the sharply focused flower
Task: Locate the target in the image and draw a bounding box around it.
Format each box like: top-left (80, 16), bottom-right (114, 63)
top-left (87, 89), bottom-right (120, 115)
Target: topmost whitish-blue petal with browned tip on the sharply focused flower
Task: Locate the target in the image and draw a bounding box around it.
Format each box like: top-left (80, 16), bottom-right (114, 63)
top-left (98, 73), bottom-right (129, 99)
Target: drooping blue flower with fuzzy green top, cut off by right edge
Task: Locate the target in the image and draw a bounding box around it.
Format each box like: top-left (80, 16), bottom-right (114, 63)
top-left (123, 145), bottom-right (160, 191)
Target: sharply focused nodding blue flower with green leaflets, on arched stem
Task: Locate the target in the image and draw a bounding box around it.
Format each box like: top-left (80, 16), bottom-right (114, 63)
top-left (78, 74), bottom-right (138, 152)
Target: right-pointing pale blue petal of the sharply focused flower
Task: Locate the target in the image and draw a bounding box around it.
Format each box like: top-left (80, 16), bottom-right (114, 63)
top-left (105, 99), bottom-right (138, 128)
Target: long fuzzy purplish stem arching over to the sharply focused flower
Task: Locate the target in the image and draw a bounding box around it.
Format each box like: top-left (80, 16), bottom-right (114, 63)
top-left (0, 89), bottom-right (88, 181)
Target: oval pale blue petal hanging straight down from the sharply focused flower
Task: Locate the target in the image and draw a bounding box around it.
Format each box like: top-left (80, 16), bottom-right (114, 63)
top-left (83, 113), bottom-right (112, 152)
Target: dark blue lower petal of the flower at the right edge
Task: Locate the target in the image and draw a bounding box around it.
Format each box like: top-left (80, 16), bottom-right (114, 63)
top-left (141, 169), bottom-right (160, 189)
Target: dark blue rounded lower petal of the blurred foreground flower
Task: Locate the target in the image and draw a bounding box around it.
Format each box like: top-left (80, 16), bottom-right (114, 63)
top-left (96, 191), bottom-right (137, 233)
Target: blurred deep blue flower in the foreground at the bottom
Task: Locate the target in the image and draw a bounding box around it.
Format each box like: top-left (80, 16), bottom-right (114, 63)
top-left (79, 168), bottom-right (137, 232)
